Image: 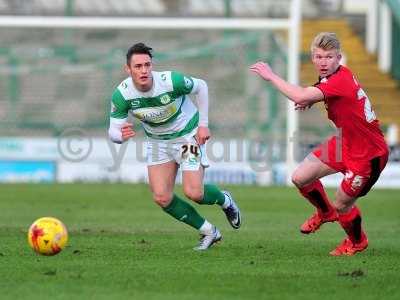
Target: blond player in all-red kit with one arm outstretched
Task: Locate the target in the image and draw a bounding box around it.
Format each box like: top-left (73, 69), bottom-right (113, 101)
top-left (250, 32), bottom-right (389, 256)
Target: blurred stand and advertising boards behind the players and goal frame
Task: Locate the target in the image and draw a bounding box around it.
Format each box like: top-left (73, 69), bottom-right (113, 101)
top-left (0, 0), bottom-right (400, 187)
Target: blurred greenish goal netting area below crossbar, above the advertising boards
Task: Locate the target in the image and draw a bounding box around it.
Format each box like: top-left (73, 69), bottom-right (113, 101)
top-left (0, 29), bottom-right (286, 139)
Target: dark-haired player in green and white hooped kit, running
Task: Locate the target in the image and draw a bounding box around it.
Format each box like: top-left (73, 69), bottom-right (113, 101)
top-left (109, 43), bottom-right (241, 250)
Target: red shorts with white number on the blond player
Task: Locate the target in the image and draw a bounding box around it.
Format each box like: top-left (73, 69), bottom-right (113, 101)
top-left (313, 136), bottom-right (389, 198)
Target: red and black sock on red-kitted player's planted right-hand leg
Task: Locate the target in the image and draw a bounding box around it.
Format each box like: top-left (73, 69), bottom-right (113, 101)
top-left (339, 206), bottom-right (366, 243)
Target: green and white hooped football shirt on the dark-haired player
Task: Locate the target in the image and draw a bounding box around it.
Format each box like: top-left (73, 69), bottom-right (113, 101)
top-left (110, 71), bottom-right (202, 140)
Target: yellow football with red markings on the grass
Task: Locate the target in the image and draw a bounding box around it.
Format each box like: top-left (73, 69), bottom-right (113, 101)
top-left (28, 217), bottom-right (68, 255)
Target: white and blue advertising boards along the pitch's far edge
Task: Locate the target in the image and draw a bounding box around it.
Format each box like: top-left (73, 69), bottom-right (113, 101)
top-left (0, 138), bottom-right (400, 188)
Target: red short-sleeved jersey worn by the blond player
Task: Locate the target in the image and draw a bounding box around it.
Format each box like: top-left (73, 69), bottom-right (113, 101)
top-left (315, 66), bottom-right (388, 160)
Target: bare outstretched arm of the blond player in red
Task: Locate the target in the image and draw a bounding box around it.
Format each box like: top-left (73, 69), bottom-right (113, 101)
top-left (250, 62), bottom-right (324, 106)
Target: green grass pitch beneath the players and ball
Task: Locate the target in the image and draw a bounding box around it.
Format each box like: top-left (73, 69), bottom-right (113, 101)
top-left (0, 184), bottom-right (400, 300)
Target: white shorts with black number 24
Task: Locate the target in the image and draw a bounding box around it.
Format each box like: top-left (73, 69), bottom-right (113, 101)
top-left (147, 136), bottom-right (209, 171)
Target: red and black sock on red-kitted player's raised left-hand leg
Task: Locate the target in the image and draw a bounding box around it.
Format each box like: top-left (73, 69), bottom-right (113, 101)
top-left (299, 179), bottom-right (335, 215)
